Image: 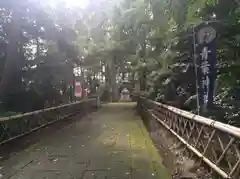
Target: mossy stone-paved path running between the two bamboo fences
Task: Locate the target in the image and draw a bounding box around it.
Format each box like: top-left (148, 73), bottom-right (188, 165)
top-left (0, 103), bottom-right (170, 179)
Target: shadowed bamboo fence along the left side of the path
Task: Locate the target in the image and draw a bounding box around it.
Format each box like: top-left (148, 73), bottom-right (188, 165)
top-left (0, 98), bottom-right (98, 145)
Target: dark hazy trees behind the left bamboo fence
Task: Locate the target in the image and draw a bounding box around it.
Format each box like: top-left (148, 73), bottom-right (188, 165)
top-left (0, 1), bottom-right (77, 112)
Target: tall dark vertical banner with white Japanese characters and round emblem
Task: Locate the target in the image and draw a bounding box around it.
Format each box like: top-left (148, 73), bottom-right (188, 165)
top-left (194, 23), bottom-right (216, 112)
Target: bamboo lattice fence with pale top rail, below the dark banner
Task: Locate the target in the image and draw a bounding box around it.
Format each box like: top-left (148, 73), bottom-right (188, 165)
top-left (135, 96), bottom-right (240, 179)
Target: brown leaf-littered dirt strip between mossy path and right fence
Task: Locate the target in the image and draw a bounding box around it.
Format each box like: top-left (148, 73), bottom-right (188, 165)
top-left (143, 114), bottom-right (211, 179)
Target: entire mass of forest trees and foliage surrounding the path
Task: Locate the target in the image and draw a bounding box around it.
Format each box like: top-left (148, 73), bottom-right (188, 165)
top-left (0, 0), bottom-right (240, 126)
